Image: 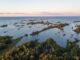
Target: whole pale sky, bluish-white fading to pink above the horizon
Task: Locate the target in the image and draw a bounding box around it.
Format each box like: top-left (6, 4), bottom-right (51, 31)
top-left (0, 0), bottom-right (80, 16)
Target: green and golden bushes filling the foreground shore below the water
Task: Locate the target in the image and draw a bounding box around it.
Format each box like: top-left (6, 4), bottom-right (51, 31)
top-left (0, 38), bottom-right (80, 60)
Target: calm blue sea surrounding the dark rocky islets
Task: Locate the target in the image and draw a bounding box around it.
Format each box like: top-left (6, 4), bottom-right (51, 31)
top-left (0, 16), bottom-right (80, 47)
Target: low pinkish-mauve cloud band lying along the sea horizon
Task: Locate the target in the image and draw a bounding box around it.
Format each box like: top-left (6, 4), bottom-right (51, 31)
top-left (0, 12), bottom-right (80, 16)
